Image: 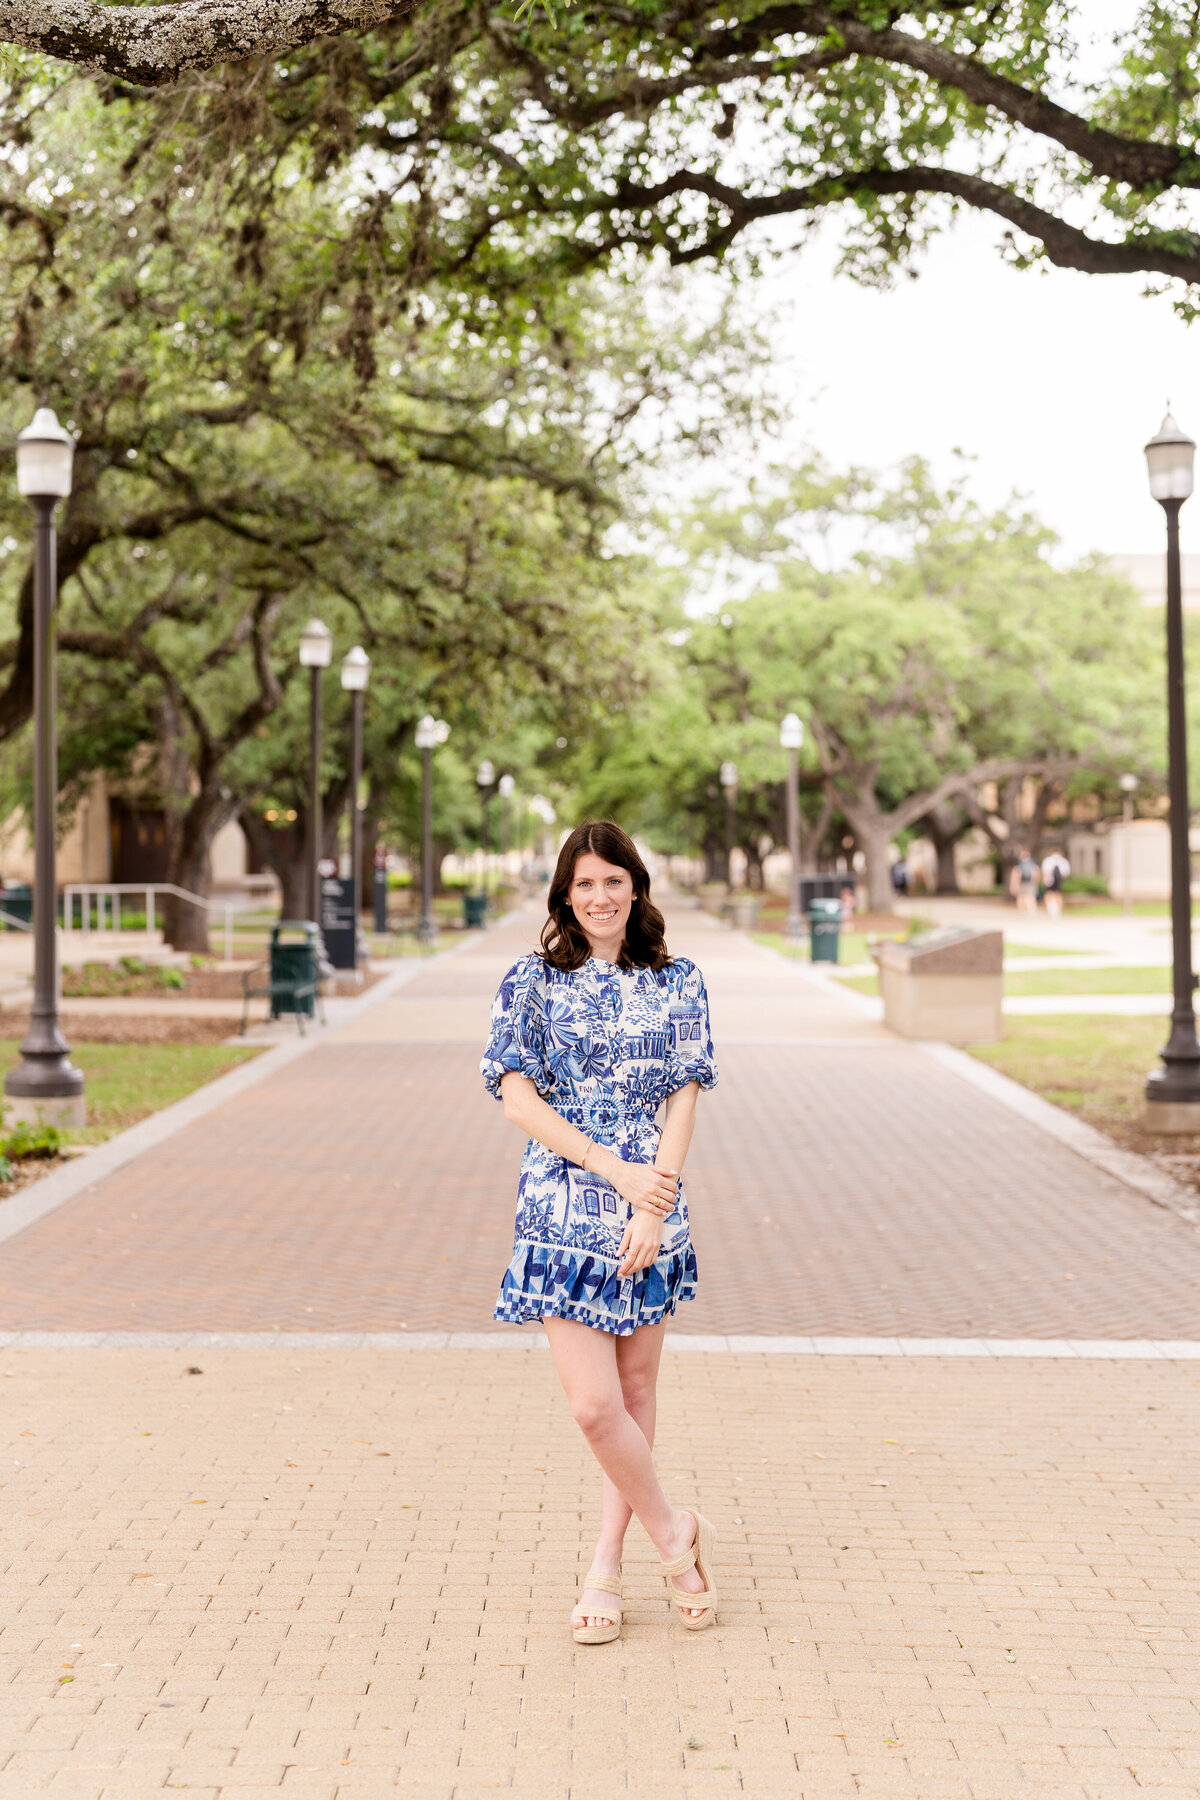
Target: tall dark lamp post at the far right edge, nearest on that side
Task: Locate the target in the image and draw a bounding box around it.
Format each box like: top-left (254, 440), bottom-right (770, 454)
top-left (1146, 412), bottom-right (1200, 1132)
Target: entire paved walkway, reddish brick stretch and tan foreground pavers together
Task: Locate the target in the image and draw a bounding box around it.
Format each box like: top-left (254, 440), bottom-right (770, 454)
top-left (0, 900), bottom-right (1200, 1800)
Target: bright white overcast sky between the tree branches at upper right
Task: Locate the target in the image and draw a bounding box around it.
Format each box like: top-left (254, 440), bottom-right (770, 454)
top-left (683, 0), bottom-right (1200, 558)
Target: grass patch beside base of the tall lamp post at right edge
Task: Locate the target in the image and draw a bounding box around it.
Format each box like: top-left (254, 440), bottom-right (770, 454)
top-left (972, 1015), bottom-right (1166, 1148)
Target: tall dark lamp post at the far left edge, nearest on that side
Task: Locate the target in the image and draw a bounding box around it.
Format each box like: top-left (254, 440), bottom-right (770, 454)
top-left (4, 407), bottom-right (86, 1127)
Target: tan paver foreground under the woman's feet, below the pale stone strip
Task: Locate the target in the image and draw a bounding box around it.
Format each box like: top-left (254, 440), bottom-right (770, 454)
top-left (0, 1350), bottom-right (1200, 1800)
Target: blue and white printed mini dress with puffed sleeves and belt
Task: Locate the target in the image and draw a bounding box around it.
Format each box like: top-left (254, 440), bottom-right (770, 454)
top-left (480, 954), bottom-right (716, 1337)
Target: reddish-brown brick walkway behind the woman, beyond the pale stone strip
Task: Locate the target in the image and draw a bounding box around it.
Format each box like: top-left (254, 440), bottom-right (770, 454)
top-left (0, 900), bottom-right (1200, 1337)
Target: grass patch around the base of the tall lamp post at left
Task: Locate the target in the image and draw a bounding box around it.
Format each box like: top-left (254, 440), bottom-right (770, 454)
top-left (0, 1040), bottom-right (259, 1143)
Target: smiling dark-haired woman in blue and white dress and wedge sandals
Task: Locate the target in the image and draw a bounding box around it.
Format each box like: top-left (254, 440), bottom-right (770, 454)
top-left (480, 821), bottom-right (716, 1643)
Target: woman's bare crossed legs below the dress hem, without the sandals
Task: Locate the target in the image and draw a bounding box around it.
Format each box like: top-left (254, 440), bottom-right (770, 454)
top-left (543, 1319), bottom-right (703, 1618)
